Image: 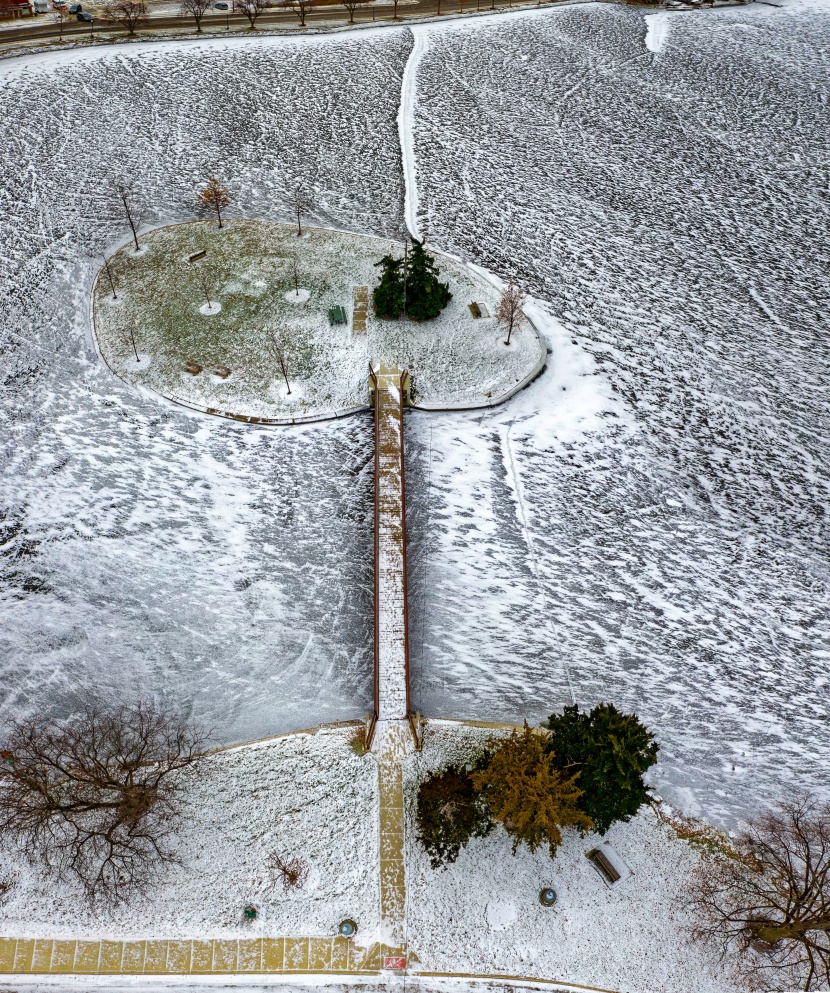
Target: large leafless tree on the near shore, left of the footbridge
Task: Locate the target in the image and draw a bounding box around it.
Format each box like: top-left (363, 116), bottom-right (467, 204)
top-left (0, 703), bottom-right (206, 902)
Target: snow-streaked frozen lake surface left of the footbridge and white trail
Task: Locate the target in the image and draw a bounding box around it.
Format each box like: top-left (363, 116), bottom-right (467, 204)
top-left (0, 31), bottom-right (409, 741)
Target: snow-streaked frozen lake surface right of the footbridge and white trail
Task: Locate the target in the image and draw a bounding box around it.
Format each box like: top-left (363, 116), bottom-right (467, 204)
top-left (407, 4), bottom-right (830, 822)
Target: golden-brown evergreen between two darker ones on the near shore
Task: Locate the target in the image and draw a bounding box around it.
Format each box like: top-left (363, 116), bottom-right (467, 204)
top-left (472, 725), bottom-right (593, 858)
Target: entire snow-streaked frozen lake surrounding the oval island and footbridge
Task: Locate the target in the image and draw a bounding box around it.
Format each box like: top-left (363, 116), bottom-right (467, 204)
top-left (0, 3), bottom-right (830, 836)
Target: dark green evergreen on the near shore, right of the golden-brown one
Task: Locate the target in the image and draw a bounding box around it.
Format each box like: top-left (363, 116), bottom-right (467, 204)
top-left (546, 703), bottom-right (659, 834)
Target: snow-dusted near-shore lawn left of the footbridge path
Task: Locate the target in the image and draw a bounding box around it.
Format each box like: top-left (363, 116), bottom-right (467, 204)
top-left (0, 727), bottom-right (379, 938)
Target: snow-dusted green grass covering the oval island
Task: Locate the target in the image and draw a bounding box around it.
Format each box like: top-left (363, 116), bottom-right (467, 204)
top-left (94, 221), bottom-right (542, 418)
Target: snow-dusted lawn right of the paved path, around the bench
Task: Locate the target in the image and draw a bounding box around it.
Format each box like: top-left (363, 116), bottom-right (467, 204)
top-left (405, 721), bottom-right (739, 993)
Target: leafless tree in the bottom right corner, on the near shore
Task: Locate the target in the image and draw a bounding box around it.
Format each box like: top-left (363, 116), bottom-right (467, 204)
top-left (690, 797), bottom-right (830, 990)
